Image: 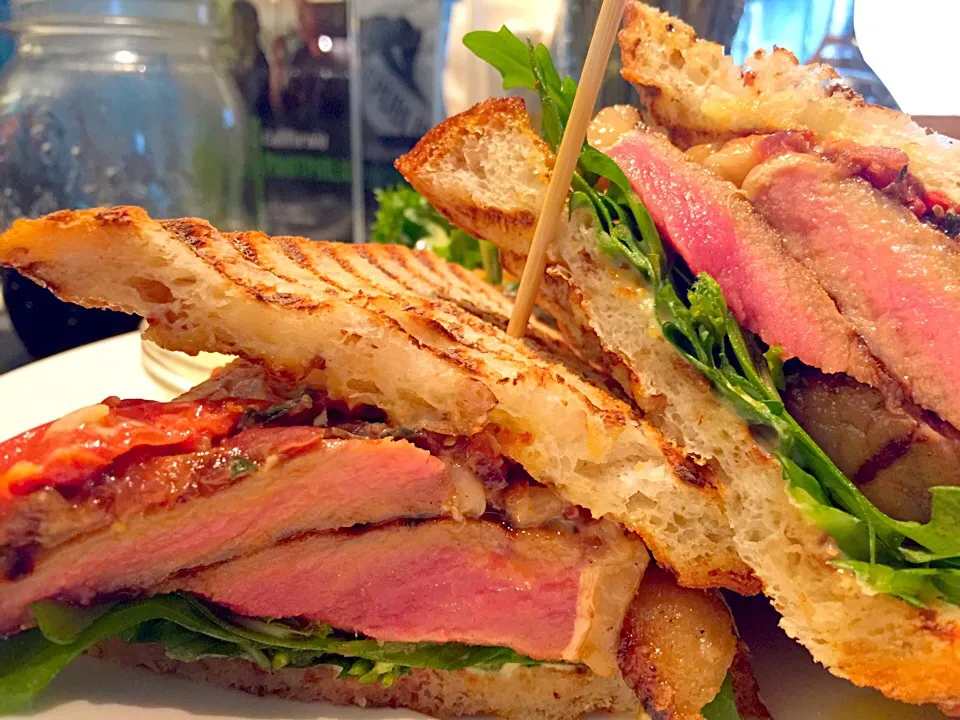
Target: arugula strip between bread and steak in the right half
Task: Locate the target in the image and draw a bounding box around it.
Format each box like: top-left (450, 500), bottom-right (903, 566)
top-left (464, 27), bottom-right (960, 606)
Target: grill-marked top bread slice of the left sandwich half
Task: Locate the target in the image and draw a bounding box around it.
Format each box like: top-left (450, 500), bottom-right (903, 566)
top-left (0, 208), bottom-right (759, 592)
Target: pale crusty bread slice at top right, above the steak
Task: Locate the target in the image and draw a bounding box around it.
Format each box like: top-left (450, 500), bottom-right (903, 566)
top-left (620, 0), bottom-right (960, 204)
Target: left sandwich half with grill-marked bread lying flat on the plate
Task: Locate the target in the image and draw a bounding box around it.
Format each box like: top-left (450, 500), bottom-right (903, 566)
top-left (0, 208), bottom-right (766, 718)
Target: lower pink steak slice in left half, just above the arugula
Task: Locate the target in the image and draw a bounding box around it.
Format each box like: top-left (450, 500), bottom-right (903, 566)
top-left (171, 520), bottom-right (647, 675)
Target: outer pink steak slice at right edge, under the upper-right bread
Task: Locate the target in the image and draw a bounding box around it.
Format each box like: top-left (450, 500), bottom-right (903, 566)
top-left (743, 153), bottom-right (960, 427)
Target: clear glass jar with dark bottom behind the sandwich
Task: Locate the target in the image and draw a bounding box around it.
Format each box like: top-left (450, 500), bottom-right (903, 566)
top-left (0, 0), bottom-right (251, 357)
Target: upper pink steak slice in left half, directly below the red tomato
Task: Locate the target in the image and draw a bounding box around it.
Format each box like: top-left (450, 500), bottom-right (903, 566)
top-left (0, 427), bottom-right (472, 634)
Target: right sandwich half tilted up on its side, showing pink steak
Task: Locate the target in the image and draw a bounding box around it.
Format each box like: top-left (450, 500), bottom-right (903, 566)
top-left (397, 2), bottom-right (960, 713)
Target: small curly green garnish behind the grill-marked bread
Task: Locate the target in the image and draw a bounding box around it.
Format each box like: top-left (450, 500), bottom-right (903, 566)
top-left (370, 185), bottom-right (503, 285)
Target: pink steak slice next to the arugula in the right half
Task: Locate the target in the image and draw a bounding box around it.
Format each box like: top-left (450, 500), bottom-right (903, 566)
top-left (606, 130), bottom-right (877, 383)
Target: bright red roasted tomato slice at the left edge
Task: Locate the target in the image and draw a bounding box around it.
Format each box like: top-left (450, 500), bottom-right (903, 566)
top-left (0, 398), bottom-right (269, 501)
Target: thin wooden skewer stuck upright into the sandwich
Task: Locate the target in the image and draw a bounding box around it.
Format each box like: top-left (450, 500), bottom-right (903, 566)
top-left (507, 0), bottom-right (626, 337)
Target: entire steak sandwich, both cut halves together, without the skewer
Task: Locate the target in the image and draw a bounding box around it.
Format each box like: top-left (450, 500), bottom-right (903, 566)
top-left (0, 3), bottom-right (960, 720)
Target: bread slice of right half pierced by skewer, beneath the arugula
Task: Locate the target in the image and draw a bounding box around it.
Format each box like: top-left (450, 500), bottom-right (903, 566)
top-left (397, 99), bottom-right (960, 707)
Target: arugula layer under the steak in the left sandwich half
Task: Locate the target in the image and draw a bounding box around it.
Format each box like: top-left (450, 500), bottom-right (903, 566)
top-left (0, 593), bottom-right (539, 713)
